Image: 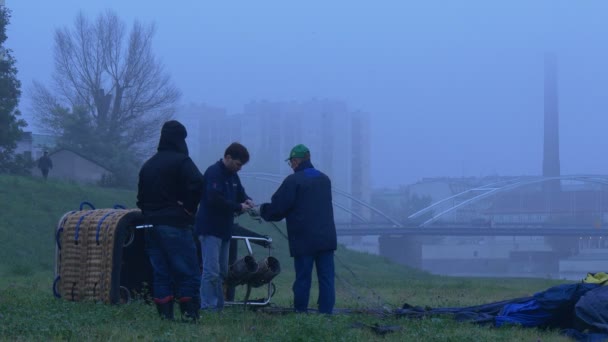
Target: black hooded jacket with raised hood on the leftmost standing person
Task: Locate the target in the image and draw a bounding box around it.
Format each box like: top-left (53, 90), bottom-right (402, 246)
top-left (137, 120), bottom-right (203, 228)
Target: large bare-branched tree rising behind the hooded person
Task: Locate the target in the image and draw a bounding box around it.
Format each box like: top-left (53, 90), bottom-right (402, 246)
top-left (31, 11), bottom-right (180, 168)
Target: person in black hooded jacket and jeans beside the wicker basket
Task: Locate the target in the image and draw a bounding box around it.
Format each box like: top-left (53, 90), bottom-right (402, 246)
top-left (137, 121), bottom-right (203, 320)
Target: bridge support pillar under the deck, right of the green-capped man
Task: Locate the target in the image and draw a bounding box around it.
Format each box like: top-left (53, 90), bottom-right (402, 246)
top-left (378, 235), bottom-right (422, 268)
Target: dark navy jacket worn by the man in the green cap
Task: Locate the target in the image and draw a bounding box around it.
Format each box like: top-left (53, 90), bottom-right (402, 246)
top-left (260, 160), bottom-right (337, 257)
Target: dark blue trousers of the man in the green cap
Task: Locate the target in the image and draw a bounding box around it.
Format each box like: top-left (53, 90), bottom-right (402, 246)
top-left (292, 251), bottom-right (336, 314)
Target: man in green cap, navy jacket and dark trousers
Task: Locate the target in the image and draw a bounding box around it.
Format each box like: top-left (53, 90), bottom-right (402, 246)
top-left (259, 144), bottom-right (337, 314)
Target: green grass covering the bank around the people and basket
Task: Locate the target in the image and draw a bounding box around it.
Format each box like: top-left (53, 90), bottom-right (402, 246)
top-left (0, 175), bottom-right (568, 341)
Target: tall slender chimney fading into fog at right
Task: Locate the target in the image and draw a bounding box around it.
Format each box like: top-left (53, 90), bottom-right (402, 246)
top-left (543, 53), bottom-right (561, 193)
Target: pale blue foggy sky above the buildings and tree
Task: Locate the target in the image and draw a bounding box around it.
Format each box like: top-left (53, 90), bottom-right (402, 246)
top-left (6, 0), bottom-right (608, 186)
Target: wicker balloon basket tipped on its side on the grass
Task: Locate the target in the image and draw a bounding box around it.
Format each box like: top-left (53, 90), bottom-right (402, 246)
top-left (53, 202), bottom-right (152, 303)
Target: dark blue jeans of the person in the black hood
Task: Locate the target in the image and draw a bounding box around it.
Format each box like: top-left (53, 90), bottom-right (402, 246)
top-left (146, 226), bottom-right (201, 299)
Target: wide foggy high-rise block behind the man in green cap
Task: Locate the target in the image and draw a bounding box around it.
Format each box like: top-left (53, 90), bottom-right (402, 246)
top-left (242, 100), bottom-right (371, 222)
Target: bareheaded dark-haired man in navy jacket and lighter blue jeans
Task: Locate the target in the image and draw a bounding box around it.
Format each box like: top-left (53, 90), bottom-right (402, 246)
top-left (196, 143), bottom-right (253, 311)
